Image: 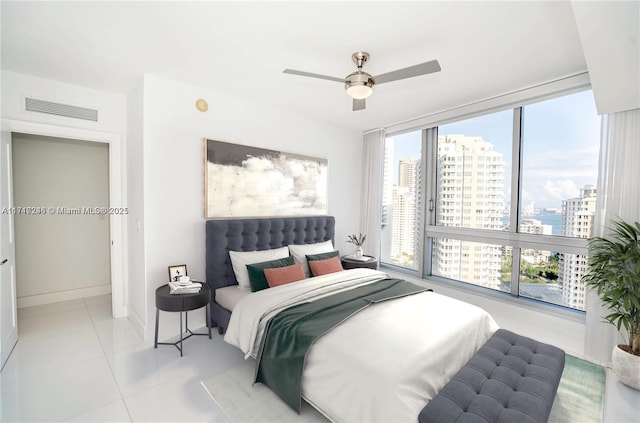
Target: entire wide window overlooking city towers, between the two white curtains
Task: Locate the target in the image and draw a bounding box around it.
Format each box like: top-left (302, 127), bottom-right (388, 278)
top-left (381, 91), bottom-right (600, 310)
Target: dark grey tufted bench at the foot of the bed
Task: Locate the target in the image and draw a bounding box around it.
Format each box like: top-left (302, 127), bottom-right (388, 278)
top-left (418, 329), bottom-right (564, 423)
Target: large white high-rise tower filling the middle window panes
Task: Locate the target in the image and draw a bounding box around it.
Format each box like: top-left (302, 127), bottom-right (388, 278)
top-left (432, 134), bottom-right (504, 289)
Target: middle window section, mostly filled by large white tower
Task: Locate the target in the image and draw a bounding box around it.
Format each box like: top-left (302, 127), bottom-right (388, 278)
top-left (431, 110), bottom-right (513, 291)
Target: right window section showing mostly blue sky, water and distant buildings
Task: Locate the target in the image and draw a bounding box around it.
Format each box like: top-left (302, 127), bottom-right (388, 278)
top-left (518, 91), bottom-right (600, 310)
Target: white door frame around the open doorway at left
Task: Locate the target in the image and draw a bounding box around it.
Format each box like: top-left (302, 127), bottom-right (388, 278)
top-left (2, 119), bottom-right (128, 318)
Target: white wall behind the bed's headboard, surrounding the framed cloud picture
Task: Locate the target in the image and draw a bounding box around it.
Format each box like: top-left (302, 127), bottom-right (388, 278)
top-left (134, 75), bottom-right (362, 338)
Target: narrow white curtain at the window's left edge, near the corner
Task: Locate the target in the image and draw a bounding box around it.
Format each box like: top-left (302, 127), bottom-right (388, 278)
top-left (360, 129), bottom-right (386, 260)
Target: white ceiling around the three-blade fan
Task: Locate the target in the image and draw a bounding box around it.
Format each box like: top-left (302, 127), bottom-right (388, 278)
top-left (1, 0), bottom-right (587, 130)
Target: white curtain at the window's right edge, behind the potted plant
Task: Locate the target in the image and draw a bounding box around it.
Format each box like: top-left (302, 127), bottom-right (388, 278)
top-left (584, 109), bottom-right (640, 365)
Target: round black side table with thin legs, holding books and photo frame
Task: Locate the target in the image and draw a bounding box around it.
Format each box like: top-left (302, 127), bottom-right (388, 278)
top-left (154, 283), bottom-right (211, 357)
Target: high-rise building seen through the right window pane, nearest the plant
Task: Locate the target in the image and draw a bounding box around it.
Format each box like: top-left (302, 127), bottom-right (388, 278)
top-left (558, 185), bottom-right (596, 310)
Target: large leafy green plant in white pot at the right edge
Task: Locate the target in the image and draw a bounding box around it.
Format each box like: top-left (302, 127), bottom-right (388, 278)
top-left (582, 220), bottom-right (640, 390)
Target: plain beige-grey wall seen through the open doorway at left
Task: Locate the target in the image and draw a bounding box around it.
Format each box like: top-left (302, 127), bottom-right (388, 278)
top-left (12, 134), bottom-right (111, 307)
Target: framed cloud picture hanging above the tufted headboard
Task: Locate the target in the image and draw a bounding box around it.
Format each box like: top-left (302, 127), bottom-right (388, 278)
top-left (205, 139), bottom-right (328, 218)
